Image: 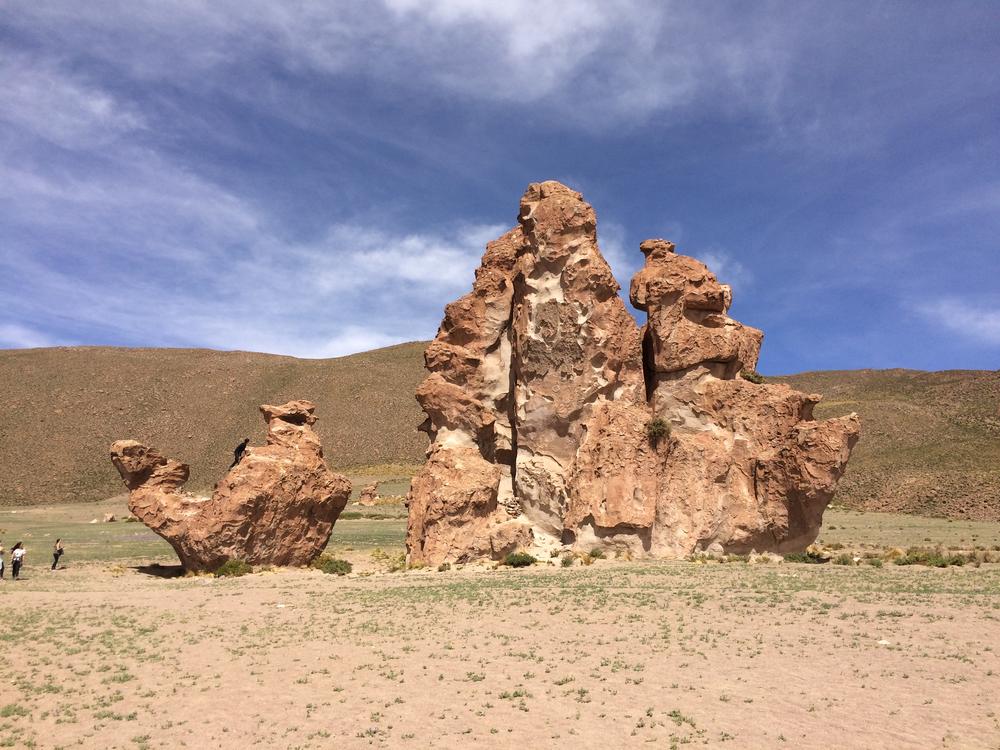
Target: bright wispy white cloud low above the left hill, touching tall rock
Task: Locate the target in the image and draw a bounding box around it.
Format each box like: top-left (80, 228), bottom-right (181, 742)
top-left (0, 50), bottom-right (507, 357)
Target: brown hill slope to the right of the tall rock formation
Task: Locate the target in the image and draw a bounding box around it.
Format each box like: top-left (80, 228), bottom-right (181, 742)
top-left (772, 370), bottom-right (1000, 520)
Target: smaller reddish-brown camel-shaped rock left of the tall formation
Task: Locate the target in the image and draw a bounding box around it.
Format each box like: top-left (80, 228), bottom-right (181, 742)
top-left (111, 401), bottom-right (351, 571)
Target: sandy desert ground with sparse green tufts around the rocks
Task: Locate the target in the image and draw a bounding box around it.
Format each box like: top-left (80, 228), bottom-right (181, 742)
top-left (0, 499), bottom-right (1000, 748)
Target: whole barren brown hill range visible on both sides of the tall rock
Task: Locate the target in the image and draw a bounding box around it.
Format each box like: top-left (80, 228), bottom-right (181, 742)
top-left (0, 342), bottom-right (1000, 520)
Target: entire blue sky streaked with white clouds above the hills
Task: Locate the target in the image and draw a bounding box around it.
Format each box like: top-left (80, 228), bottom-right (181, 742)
top-left (0, 0), bottom-right (1000, 373)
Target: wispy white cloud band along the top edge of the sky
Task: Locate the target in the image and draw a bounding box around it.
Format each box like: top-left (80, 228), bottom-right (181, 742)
top-left (0, 0), bottom-right (828, 130)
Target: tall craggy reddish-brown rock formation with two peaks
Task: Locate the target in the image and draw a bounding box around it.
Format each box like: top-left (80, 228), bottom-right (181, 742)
top-left (407, 182), bottom-right (860, 564)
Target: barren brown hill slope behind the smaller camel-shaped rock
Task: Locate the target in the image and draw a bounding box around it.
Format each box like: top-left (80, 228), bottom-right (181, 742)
top-left (0, 343), bottom-right (427, 505)
